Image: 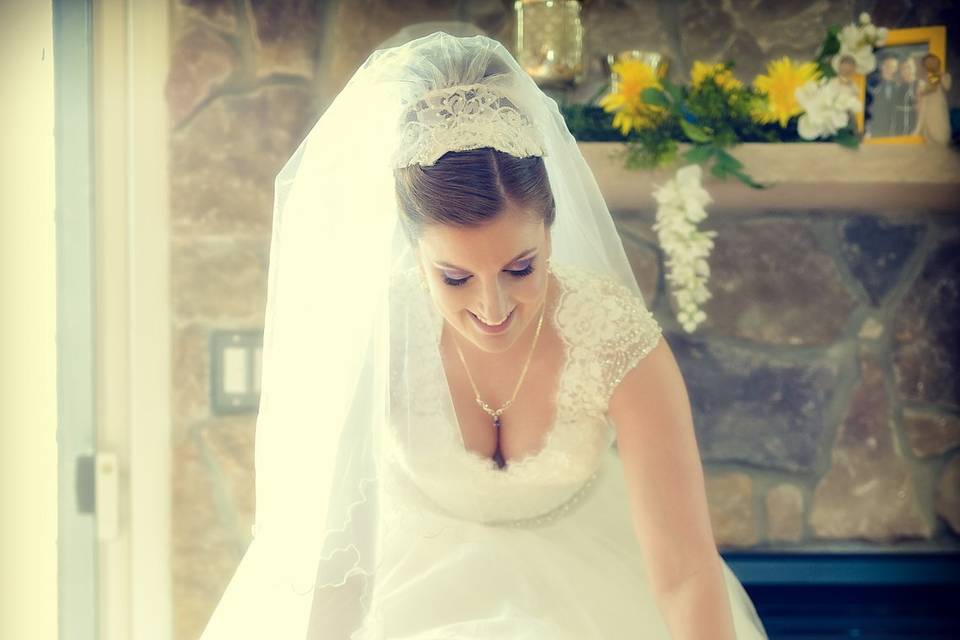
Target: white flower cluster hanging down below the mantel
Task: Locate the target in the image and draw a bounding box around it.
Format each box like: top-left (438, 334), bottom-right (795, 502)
top-left (653, 164), bottom-right (716, 332)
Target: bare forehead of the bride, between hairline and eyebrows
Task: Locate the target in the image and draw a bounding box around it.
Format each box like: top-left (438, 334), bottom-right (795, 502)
top-left (420, 208), bottom-right (546, 269)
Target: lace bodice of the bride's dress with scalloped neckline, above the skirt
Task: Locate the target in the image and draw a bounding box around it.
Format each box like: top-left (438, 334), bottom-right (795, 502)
top-left (384, 265), bottom-right (662, 525)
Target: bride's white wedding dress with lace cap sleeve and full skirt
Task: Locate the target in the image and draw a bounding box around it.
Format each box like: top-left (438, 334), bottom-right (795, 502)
top-left (351, 265), bottom-right (766, 640)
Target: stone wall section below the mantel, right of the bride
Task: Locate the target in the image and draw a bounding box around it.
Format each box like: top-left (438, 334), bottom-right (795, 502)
top-left (616, 211), bottom-right (960, 551)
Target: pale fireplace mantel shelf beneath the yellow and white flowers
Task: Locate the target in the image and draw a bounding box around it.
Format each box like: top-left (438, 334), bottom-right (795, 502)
top-left (579, 142), bottom-right (960, 213)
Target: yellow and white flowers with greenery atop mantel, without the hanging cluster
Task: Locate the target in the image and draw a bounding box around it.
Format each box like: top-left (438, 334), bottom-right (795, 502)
top-left (580, 13), bottom-right (887, 176)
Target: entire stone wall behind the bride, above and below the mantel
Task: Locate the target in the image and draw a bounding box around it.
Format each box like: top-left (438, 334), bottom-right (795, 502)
top-left (167, 0), bottom-right (960, 639)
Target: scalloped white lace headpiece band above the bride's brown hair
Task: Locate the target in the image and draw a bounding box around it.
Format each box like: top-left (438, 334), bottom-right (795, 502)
top-left (394, 84), bottom-right (546, 167)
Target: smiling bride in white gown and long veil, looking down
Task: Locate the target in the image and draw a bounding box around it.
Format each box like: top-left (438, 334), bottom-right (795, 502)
top-left (202, 32), bottom-right (766, 640)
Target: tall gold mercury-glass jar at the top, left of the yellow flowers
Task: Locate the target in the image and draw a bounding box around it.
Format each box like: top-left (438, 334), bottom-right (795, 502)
top-left (513, 0), bottom-right (583, 86)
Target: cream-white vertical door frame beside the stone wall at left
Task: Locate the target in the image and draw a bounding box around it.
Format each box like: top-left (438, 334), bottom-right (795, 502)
top-left (92, 0), bottom-right (173, 640)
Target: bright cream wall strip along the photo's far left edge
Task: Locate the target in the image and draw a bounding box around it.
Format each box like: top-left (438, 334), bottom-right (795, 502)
top-left (0, 0), bottom-right (57, 640)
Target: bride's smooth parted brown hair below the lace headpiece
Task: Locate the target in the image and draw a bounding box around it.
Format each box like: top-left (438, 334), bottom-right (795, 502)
top-left (394, 147), bottom-right (556, 241)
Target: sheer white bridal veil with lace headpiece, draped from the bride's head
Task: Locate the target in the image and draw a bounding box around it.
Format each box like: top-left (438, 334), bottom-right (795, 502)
top-left (201, 32), bottom-right (652, 640)
